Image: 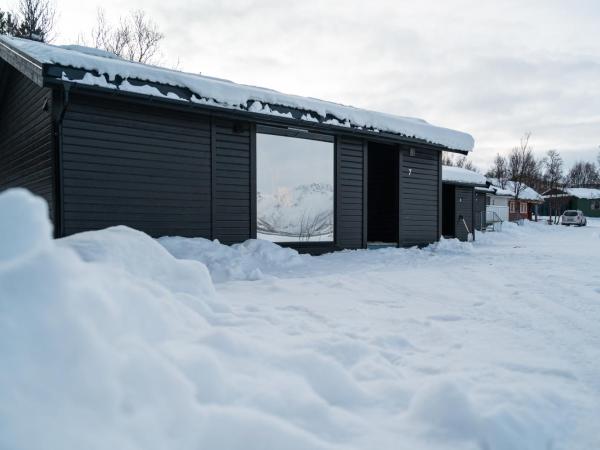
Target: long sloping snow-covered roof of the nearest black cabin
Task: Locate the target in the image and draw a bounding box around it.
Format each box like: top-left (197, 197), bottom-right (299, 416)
top-left (0, 36), bottom-right (474, 152)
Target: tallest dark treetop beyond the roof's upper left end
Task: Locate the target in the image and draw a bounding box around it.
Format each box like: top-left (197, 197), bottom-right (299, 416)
top-left (11, 0), bottom-right (56, 42)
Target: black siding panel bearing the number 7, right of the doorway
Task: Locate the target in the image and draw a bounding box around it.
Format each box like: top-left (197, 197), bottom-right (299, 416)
top-left (399, 147), bottom-right (442, 246)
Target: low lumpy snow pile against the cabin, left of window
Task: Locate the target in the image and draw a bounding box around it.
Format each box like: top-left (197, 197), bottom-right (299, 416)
top-left (158, 237), bottom-right (303, 283)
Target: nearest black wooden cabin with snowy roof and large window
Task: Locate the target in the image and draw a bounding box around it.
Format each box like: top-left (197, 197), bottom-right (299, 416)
top-left (0, 36), bottom-right (473, 253)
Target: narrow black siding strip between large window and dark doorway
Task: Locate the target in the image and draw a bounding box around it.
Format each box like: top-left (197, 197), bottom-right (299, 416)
top-left (335, 137), bottom-right (366, 248)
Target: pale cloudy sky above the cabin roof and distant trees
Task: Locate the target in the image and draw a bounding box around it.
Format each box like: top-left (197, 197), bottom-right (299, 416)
top-left (43, 0), bottom-right (600, 169)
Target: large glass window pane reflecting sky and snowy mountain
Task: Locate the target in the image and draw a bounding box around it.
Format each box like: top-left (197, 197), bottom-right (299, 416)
top-left (256, 133), bottom-right (334, 242)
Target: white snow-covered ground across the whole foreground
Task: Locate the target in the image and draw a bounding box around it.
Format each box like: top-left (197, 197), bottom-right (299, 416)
top-left (0, 191), bottom-right (600, 450)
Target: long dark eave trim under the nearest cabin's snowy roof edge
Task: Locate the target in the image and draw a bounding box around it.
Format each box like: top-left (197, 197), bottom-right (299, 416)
top-left (44, 77), bottom-right (468, 155)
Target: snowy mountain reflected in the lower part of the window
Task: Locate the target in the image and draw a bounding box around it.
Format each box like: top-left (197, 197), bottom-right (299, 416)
top-left (257, 183), bottom-right (333, 242)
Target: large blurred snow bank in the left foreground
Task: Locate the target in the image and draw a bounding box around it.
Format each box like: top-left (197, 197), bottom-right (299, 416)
top-left (0, 190), bottom-right (331, 450)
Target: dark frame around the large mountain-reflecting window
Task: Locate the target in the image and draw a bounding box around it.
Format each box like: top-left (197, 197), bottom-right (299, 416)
top-left (252, 124), bottom-right (338, 244)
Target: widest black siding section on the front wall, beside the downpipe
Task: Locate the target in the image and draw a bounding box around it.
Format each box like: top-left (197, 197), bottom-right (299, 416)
top-left (61, 95), bottom-right (211, 237)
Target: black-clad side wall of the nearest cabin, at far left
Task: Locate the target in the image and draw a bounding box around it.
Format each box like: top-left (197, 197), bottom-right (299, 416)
top-left (0, 62), bottom-right (55, 219)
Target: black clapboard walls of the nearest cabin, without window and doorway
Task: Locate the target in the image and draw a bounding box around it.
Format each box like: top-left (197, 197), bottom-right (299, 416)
top-left (0, 78), bottom-right (450, 253)
